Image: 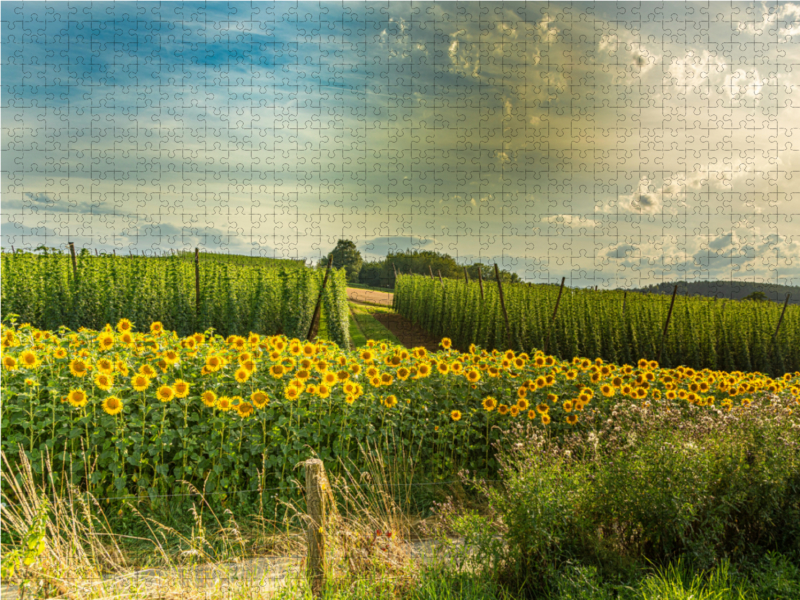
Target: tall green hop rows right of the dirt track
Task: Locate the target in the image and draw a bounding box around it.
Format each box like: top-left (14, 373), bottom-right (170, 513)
top-left (393, 275), bottom-right (800, 375)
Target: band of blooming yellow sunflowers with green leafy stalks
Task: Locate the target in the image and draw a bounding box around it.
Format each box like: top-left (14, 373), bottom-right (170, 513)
top-left (0, 316), bottom-right (800, 512)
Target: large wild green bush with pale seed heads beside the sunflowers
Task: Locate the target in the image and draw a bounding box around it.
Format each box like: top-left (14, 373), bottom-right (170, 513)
top-left (456, 396), bottom-right (800, 593)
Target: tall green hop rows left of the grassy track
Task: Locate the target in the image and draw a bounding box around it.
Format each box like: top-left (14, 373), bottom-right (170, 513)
top-left (2, 252), bottom-right (349, 347)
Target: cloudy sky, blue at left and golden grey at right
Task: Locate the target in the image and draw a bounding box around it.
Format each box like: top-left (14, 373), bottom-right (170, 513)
top-left (0, 1), bottom-right (800, 288)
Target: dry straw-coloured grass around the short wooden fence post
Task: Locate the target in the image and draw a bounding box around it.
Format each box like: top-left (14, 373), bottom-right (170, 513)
top-left (0, 438), bottom-right (438, 600)
